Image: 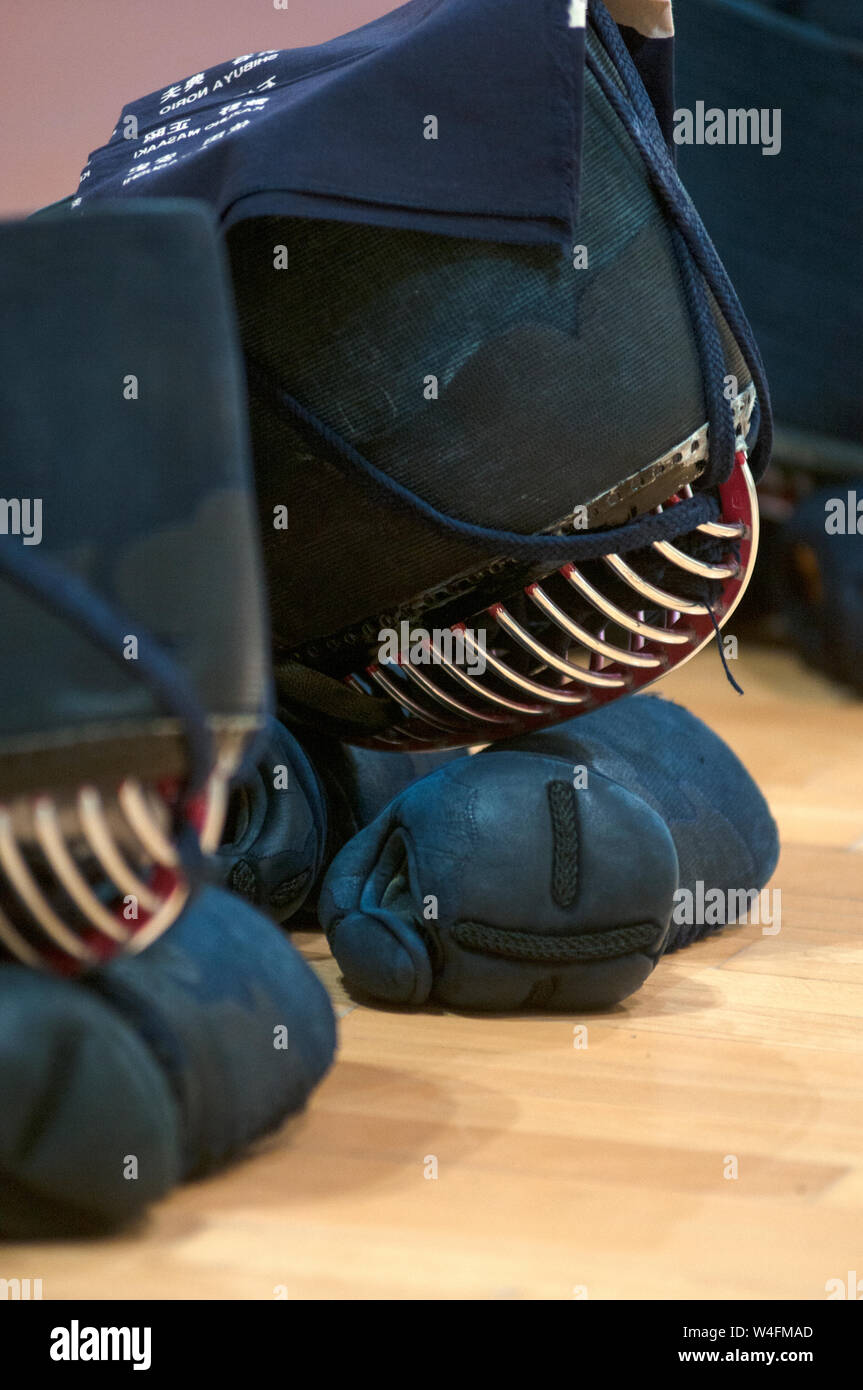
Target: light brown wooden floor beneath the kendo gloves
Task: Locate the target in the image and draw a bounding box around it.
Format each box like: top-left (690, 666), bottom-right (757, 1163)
top-left (4, 651), bottom-right (863, 1300)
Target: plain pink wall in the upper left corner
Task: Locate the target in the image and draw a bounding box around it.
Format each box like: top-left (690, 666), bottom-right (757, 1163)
top-left (0, 0), bottom-right (391, 217)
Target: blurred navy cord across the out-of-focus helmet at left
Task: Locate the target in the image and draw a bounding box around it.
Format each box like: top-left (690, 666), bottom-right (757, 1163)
top-left (0, 537), bottom-right (214, 811)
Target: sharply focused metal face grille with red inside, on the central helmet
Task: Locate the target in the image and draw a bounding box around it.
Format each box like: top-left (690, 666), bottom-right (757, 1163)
top-left (347, 435), bottom-right (759, 751)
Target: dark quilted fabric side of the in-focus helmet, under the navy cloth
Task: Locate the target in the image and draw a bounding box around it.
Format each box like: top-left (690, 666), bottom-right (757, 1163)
top-left (229, 31), bottom-right (749, 673)
